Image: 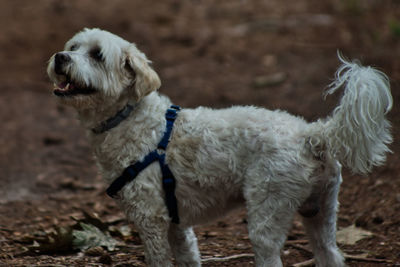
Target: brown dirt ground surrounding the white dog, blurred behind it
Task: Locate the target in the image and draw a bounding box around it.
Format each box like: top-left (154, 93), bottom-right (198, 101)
top-left (0, 0), bottom-right (400, 267)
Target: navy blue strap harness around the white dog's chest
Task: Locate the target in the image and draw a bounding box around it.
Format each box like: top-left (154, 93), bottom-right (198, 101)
top-left (107, 105), bottom-right (181, 224)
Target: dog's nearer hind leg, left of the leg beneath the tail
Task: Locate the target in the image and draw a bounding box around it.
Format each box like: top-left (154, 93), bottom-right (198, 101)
top-left (245, 178), bottom-right (299, 267)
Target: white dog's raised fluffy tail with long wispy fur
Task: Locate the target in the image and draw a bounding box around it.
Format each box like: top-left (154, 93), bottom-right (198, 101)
top-left (322, 56), bottom-right (393, 174)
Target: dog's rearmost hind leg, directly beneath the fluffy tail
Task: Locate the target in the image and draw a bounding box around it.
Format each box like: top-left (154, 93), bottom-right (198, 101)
top-left (303, 167), bottom-right (345, 267)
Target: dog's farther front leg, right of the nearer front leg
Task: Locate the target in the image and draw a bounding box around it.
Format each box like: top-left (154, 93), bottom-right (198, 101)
top-left (168, 224), bottom-right (201, 267)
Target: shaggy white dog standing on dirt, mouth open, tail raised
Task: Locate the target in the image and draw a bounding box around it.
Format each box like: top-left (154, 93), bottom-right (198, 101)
top-left (48, 29), bottom-right (392, 266)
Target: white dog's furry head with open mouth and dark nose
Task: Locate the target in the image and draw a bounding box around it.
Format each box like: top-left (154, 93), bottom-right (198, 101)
top-left (47, 29), bottom-right (161, 109)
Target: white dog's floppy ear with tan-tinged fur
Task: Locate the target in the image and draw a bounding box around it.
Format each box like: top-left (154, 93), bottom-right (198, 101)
top-left (125, 44), bottom-right (161, 100)
